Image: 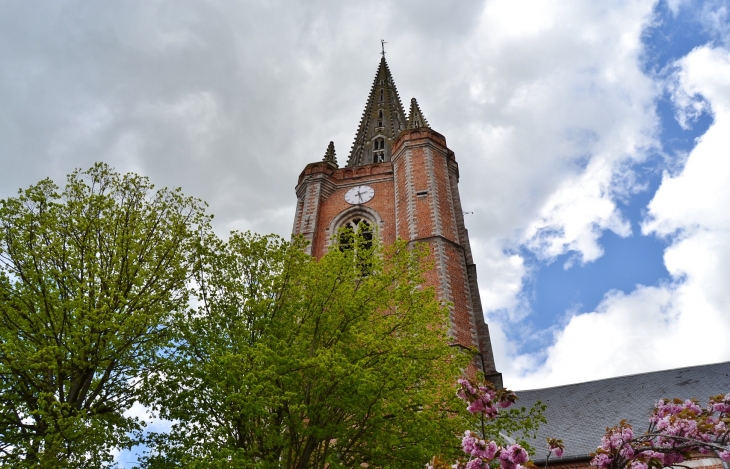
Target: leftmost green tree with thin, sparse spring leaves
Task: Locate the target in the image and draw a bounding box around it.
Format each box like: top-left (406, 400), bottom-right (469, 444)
top-left (0, 164), bottom-right (209, 468)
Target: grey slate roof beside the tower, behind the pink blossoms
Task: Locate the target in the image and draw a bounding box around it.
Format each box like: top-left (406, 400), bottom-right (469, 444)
top-left (516, 362), bottom-right (730, 462)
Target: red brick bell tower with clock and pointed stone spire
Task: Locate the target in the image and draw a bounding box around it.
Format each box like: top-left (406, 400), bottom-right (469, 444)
top-left (293, 56), bottom-right (502, 387)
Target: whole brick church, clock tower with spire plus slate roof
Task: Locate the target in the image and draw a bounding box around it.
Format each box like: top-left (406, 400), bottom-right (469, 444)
top-left (292, 55), bottom-right (730, 469)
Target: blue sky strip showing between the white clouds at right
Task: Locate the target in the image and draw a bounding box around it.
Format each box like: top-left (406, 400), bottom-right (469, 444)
top-left (507, 1), bottom-right (713, 353)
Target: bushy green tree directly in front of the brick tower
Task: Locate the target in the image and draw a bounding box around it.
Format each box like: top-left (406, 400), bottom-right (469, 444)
top-left (143, 233), bottom-right (470, 468)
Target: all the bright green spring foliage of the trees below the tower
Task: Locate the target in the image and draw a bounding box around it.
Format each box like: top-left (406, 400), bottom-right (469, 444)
top-left (0, 164), bottom-right (544, 469)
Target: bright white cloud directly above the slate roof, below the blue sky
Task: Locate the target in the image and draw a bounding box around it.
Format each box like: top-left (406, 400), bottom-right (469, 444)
top-left (511, 46), bottom-right (730, 388)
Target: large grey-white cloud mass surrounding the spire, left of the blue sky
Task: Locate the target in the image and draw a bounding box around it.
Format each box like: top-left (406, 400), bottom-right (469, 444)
top-left (0, 0), bottom-right (656, 318)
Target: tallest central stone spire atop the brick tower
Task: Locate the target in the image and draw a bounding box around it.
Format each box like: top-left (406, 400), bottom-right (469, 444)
top-left (347, 56), bottom-right (407, 167)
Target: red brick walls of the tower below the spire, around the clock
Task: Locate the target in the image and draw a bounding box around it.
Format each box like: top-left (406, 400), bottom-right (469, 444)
top-left (293, 128), bottom-right (501, 386)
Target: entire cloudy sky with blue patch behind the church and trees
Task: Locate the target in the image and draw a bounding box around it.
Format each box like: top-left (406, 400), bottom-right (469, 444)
top-left (0, 0), bottom-right (730, 460)
